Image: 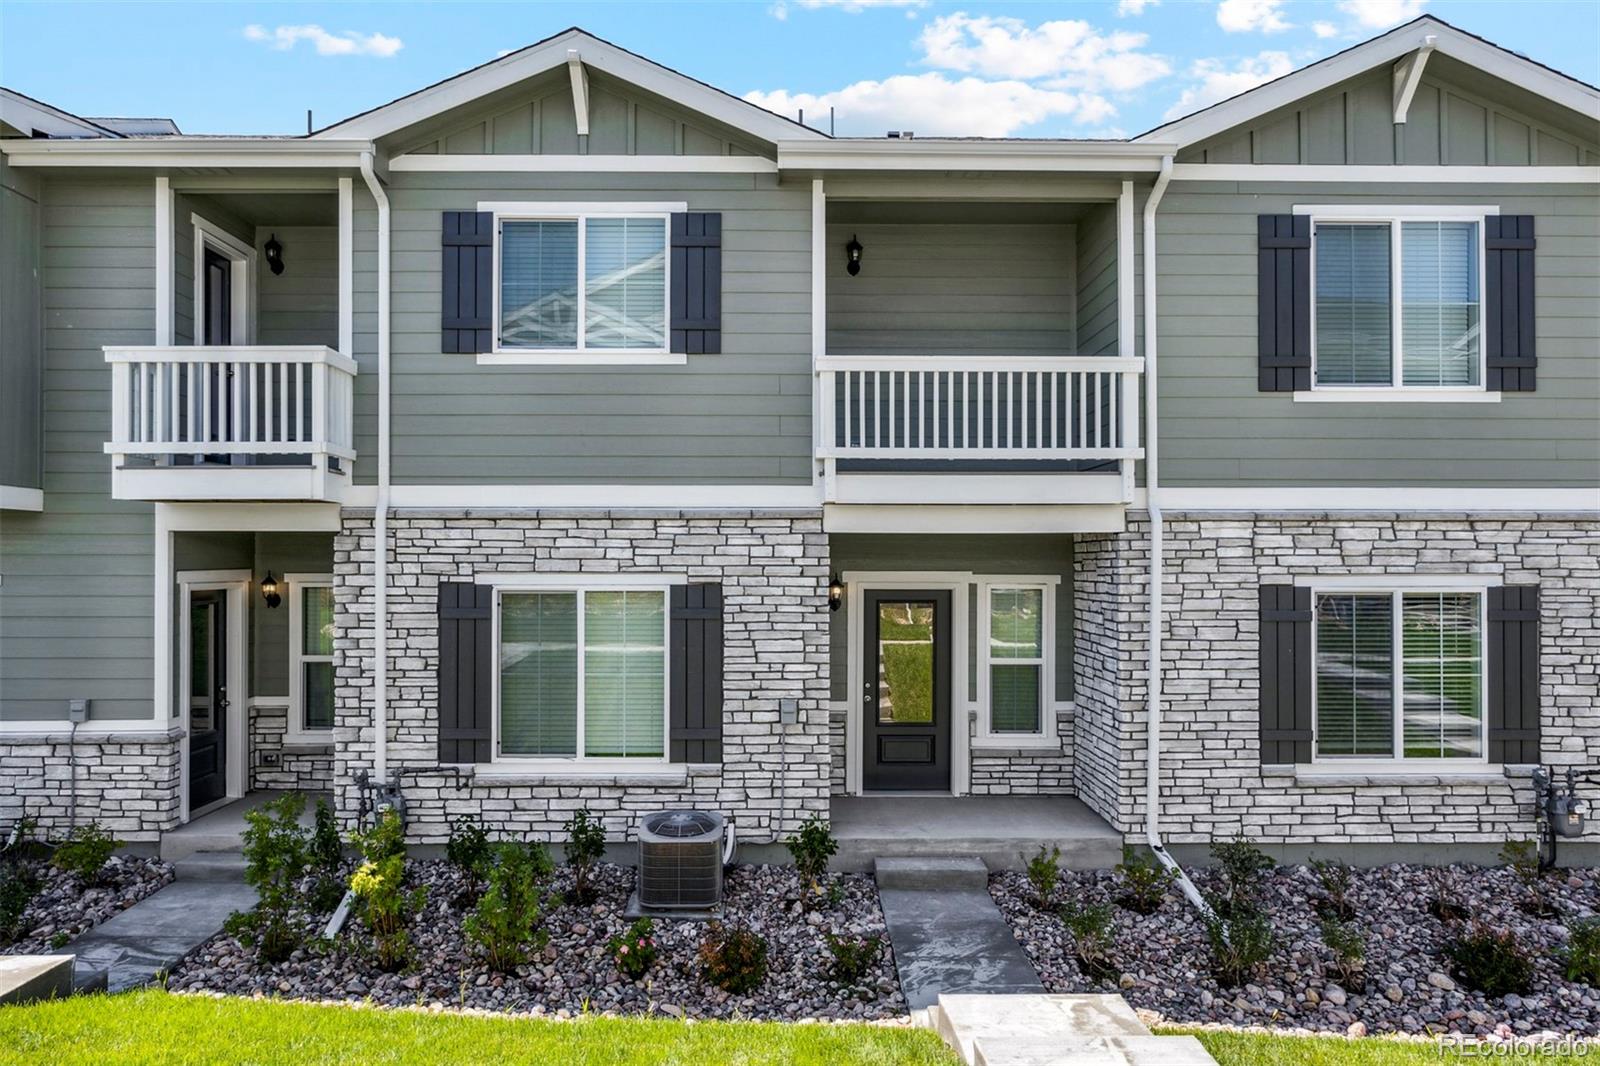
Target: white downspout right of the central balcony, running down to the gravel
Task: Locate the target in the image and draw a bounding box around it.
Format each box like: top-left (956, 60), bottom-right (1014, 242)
top-left (1144, 155), bottom-right (1211, 914)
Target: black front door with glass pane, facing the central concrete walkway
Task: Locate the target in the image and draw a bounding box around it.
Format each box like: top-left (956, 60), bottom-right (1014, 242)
top-left (861, 589), bottom-right (950, 792)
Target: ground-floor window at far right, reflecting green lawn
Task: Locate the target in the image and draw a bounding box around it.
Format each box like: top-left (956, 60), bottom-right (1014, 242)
top-left (1312, 587), bottom-right (1486, 763)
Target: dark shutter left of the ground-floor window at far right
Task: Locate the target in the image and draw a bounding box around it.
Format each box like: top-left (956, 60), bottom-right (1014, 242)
top-left (1261, 584), bottom-right (1315, 765)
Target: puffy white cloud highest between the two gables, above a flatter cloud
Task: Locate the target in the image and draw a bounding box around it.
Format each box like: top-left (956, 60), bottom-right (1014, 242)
top-left (918, 13), bottom-right (1171, 91)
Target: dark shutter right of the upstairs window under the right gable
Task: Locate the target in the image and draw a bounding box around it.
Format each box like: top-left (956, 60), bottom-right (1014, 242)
top-left (1483, 214), bottom-right (1539, 392)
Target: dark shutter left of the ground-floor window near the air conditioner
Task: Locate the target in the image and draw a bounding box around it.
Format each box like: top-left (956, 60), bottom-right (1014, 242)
top-left (438, 581), bottom-right (494, 762)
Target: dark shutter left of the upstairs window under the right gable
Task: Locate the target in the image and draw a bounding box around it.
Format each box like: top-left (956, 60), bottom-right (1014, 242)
top-left (1256, 214), bottom-right (1310, 392)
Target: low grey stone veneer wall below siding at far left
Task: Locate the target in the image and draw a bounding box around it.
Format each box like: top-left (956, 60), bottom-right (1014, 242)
top-left (0, 722), bottom-right (182, 842)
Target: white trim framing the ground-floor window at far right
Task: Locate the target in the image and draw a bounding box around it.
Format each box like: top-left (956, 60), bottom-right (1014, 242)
top-left (1294, 575), bottom-right (1494, 776)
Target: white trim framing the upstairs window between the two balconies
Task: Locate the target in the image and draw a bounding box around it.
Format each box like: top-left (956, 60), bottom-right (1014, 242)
top-left (478, 200), bottom-right (688, 367)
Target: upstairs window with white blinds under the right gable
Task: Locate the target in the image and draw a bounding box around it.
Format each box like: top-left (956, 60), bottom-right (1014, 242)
top-left (1304, 208), bottom-right (1486, 392)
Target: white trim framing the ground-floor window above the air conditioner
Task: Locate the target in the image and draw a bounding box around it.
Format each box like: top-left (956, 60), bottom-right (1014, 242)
top-left (477, 573), bottom-right (665, 775)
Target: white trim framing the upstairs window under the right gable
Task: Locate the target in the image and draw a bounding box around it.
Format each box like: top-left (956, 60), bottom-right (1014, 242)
top-left (1294, 203), bottom-right (1501, 403)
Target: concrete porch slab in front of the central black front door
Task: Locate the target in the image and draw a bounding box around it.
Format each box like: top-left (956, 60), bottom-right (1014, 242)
top-left (830, 795), bottom-right (1122, 872)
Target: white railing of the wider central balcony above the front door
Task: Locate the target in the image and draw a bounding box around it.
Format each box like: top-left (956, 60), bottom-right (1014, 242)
top-left (816, 355), bottom-right (1144, 466)
